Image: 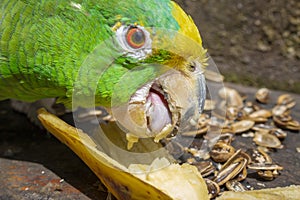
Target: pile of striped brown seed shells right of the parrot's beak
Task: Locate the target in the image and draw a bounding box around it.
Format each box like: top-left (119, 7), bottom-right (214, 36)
top-left (168, 88), bottom-right (300, 198)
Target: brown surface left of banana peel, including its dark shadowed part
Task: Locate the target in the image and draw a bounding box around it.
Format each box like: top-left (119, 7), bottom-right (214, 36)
top-left (0, 101), bottom-right (107, 200)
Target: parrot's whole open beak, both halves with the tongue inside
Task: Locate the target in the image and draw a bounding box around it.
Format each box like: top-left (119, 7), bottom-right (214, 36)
top-left (116, 62), bottom-right (206, 145)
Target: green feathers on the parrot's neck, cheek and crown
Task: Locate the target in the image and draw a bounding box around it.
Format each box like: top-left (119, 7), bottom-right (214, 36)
top-left (0, 0), bottom-right (179, 106)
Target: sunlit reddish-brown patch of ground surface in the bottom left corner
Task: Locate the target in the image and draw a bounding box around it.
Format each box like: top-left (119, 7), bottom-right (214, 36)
top-left (0, 158), bottom-right (89, 200)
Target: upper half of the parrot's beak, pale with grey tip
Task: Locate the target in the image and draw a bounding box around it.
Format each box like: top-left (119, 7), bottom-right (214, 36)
top-left (157, 62), bottom-right (206, 133)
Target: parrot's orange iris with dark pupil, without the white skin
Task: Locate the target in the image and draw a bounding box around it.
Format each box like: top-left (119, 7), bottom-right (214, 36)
top-left (126, 27), bottom-right (146, 49)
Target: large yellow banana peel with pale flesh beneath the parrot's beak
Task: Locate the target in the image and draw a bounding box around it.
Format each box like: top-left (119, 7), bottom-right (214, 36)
top-left (38, 108), bottom-right (209, 200)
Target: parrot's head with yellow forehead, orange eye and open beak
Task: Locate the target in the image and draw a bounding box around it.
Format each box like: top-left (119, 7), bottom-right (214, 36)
top-left (74, 0), bottom-right (206, 144)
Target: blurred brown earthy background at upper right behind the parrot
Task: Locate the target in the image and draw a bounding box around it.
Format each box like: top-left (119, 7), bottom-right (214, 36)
top-left (176, 0), bottom-right (300, 93)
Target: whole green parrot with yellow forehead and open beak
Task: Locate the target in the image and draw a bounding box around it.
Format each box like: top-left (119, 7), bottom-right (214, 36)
top-left (0, 0), bottom-right (207, 141)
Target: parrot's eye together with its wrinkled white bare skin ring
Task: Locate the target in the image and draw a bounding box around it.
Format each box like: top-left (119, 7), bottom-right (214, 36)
top-left (116, 25), bottom-right (152, 59)
